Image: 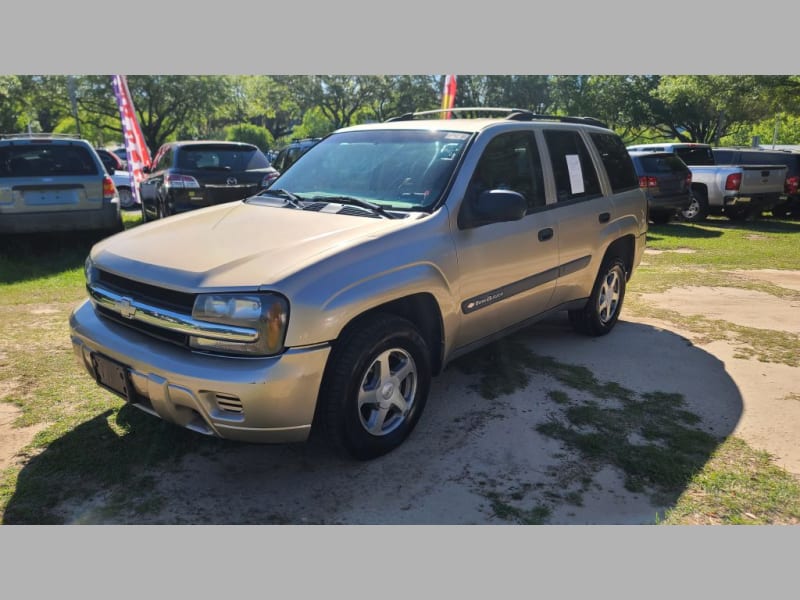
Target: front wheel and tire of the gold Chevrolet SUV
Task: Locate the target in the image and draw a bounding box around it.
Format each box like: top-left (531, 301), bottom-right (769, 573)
top-left (315, 314), bottom-right (431, 460)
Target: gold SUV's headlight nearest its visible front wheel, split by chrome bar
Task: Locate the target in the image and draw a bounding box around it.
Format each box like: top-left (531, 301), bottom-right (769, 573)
top-left (189, 294), bottom-right (289, 356)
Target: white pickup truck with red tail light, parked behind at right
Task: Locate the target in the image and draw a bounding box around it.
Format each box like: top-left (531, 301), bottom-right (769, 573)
top-left (627, 143), bottom-right (786, 221)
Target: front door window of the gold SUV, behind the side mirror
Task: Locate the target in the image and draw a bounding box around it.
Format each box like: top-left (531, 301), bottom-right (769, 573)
top-left (470, 131), bottom-right (546, 212)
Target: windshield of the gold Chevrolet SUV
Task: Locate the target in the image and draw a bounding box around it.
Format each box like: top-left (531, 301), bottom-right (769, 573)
top-left (271, 129), bottom-right (470, 210)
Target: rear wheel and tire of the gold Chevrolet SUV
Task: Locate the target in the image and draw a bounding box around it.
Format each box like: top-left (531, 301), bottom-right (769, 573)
top-left (569, 257), bottom-right (627, 336)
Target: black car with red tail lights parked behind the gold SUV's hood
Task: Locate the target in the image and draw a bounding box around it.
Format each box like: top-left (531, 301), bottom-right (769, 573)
top-left (139, 141), bottom-right (279, 221)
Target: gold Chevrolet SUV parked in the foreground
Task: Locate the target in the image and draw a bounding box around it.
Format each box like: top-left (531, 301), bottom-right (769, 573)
top-left (70, 109), bottom-right (647, 459)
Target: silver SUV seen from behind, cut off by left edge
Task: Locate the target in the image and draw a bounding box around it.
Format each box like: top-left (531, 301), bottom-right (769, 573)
top-left (0, 134), bottom-right (122, 233)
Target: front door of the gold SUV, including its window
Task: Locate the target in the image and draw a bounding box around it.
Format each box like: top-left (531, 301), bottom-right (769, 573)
top-left (454, 131), bottom-right (558, 349)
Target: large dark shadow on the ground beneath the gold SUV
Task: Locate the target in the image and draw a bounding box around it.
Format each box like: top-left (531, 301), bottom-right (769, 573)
top-left (4, 316), bottom-right (742, 524)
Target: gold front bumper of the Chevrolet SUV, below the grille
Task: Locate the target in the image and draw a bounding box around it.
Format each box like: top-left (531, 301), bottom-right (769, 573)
top-left (69, 300), bottom-right (330, 443)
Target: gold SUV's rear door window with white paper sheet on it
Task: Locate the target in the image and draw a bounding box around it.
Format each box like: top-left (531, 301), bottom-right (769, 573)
top-left (544, 130), bottom-right (600, 202)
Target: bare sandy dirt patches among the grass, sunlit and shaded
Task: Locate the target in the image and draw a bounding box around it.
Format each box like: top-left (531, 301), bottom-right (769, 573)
top-left (0, 270), bottom-right (800, 524)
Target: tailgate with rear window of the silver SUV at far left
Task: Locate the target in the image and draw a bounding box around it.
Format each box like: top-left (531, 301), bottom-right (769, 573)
top-left (0, 140), bottom-right (105, 214)
